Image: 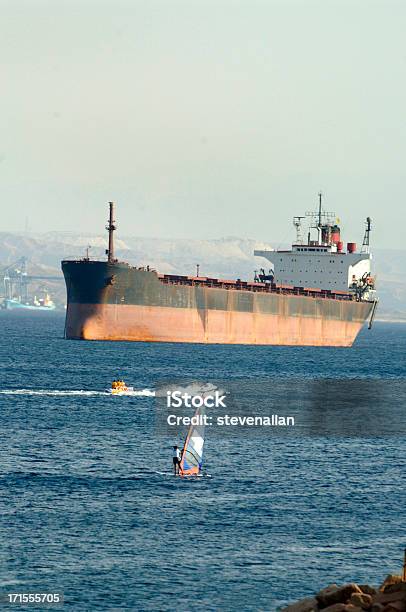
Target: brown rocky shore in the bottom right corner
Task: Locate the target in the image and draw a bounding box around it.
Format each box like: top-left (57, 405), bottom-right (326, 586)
top-left (282, 575), bottom-right (406, 612)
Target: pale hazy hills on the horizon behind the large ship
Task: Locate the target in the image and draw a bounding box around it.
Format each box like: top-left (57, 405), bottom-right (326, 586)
top-left (0, 232), bottom-right (406, 321)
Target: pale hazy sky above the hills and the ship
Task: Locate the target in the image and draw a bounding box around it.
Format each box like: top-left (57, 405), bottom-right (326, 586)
top-left (0, 0), bottom-right (406, 248)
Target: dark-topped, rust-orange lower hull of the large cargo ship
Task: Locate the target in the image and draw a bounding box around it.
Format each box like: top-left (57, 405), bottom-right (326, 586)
top-left (62, 259), bottom-right (373, 347)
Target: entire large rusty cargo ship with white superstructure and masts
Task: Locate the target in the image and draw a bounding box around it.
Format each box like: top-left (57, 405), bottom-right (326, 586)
top-left (62, 200), bottom-right (378, 347)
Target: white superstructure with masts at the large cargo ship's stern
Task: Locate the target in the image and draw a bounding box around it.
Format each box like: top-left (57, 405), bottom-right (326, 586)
top-left (254, 197), bottom-right (374, 299)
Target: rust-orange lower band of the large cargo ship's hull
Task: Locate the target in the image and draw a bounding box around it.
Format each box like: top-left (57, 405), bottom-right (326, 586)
top-left (66, 298), bottom-right (370, 346)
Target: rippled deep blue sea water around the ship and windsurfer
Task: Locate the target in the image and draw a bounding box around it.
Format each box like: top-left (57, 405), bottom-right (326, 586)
top-left (0, 314), bottom-right (406, 611)
